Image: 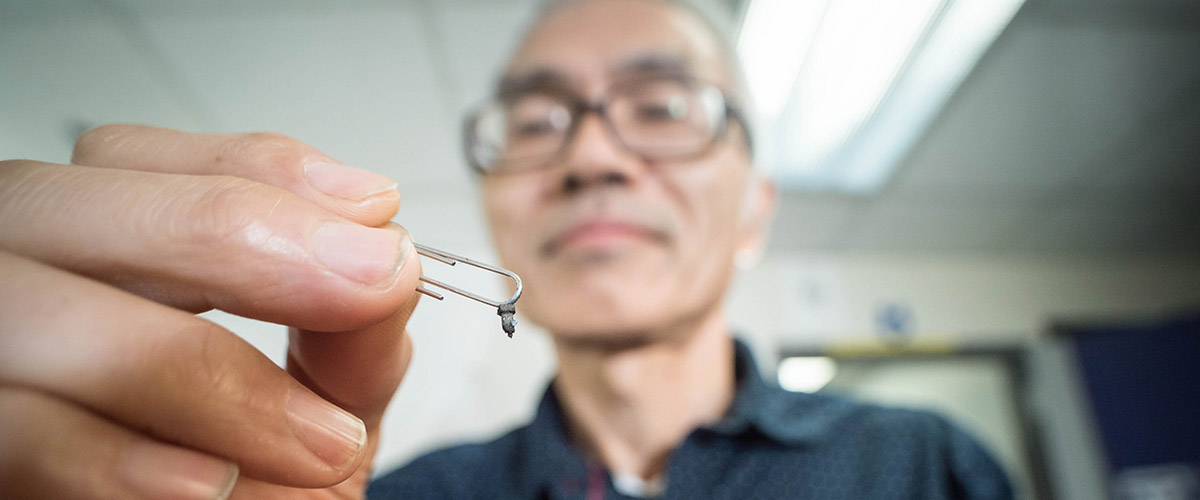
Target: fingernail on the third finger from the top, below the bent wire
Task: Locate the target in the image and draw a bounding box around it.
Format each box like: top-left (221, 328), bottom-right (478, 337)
top-left (287, 388), bottom-right (367, 470)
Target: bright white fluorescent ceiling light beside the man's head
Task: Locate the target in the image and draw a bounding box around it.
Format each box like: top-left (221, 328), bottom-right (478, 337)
top-left (738, 0), bottom-right (1024, 193)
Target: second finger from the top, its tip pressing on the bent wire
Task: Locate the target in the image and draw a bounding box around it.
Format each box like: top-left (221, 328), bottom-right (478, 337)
top-left (0, 162), bottom-right (420, 331)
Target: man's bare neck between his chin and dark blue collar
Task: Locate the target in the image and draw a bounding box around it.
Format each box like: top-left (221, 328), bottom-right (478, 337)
top-left (556, 314), bottom-right (734, 480)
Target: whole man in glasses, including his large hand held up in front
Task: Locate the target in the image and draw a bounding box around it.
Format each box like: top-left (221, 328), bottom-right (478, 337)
top-left (0, 0), bottom-right (1010, 499)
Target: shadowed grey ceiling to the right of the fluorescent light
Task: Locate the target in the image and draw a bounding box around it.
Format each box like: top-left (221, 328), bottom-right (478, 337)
top-left (774, 0), bottom-right (1200, 253)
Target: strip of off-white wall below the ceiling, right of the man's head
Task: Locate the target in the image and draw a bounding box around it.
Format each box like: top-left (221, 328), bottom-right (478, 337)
top-left (732, 253), bottom-right (1200, 348)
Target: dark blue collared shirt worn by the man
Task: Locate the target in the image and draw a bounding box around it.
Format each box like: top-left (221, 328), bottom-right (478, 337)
top-left (367, 343), bottom-right (1013, 500)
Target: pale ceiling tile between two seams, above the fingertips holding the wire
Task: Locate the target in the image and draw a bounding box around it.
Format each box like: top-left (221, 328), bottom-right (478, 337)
top-left (132, 6), bottom-right (467, 193)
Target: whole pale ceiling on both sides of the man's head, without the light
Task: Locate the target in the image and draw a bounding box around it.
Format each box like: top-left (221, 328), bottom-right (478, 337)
top-left (0, 0), bottom-right (1200, 254)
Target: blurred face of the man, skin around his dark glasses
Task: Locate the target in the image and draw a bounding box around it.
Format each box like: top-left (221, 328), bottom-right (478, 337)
top-left (484, 0), bottom-right (762, 342)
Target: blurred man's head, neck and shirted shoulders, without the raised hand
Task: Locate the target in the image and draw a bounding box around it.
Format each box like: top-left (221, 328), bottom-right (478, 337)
top-left (371, 0), bottom-right (1010, 499)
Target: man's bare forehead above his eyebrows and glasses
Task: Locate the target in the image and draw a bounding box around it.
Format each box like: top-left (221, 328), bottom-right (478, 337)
top-left (500, 0), bottom-right (731, 91)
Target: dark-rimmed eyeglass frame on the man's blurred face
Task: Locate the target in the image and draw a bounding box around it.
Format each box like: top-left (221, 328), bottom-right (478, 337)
top-left (462, 77), bottom-right (754, 176)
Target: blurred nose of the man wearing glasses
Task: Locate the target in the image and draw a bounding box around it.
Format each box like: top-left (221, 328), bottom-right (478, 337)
top-left (562, 113), bottom-right (644, 193)
